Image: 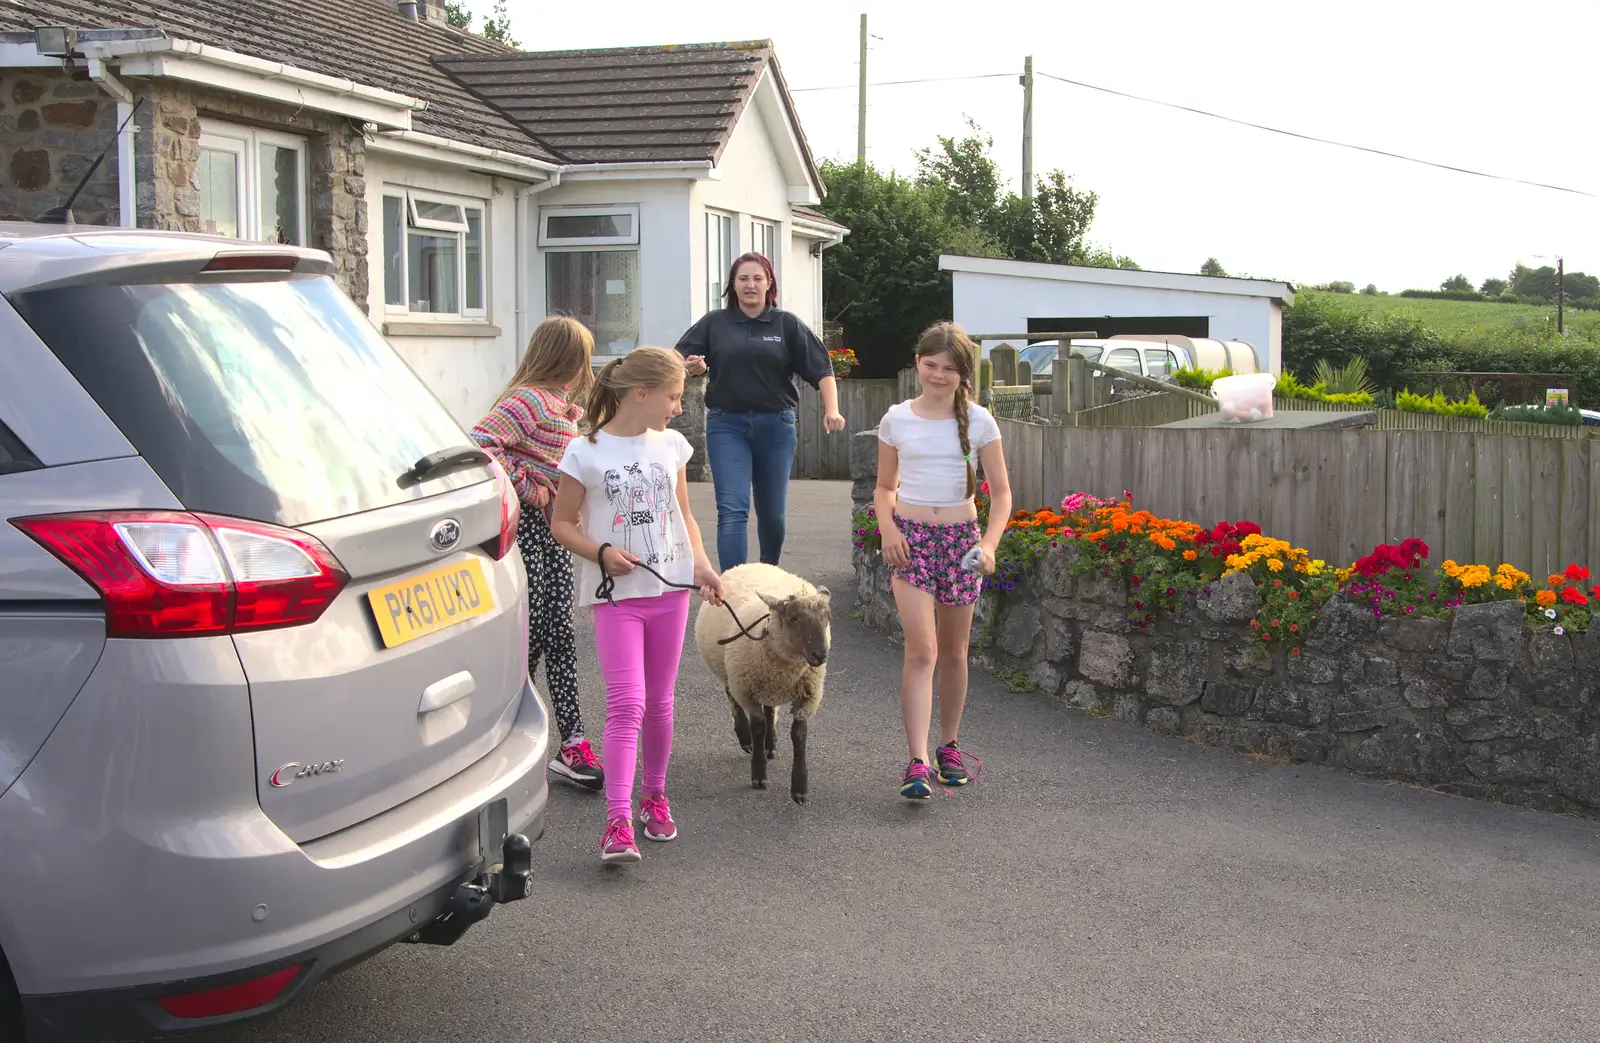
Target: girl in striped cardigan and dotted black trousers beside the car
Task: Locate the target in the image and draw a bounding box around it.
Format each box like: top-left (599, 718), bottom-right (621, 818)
top-left (472, 315), bottom-right (605, 790)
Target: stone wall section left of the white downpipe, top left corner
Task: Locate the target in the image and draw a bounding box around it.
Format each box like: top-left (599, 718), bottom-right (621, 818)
top-left (0, 69), bottom-right (120, 224)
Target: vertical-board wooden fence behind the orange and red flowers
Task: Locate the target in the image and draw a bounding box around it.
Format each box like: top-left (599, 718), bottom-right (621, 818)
top-left (1000, 421), bottom-right (1600, 579)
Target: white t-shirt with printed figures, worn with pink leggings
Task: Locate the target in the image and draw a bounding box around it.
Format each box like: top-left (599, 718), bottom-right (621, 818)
top-left (562, 429), bottom-right (694, 605)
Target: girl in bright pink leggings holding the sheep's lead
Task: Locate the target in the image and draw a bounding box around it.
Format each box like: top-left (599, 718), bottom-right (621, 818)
top-left (550, 347), bottom-right (722, 862)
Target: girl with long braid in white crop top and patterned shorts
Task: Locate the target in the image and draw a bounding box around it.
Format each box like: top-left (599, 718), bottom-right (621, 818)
top-left (874, 322), bottom-right (1011, 800)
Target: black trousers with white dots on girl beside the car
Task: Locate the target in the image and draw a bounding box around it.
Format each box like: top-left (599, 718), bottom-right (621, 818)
top-left (517, 504), bottom-right (584, 742)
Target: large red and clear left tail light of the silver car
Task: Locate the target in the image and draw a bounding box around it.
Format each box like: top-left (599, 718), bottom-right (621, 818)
top-left (11, 510), bottom-right (349, 638)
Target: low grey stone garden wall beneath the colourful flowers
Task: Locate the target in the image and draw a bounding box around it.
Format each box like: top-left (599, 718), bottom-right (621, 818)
top-left (854, 428), bottom-right (1600, 819)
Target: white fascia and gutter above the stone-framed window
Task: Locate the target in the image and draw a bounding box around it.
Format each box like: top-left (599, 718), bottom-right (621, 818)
top-left (80, 40), bottom-right (427, 130)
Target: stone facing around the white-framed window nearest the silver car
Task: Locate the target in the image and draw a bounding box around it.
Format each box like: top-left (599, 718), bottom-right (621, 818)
top-left (134, 80), bottom-right (368, 309)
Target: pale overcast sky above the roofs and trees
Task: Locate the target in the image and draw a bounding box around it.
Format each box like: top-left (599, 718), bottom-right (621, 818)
top-left (505, 0), bottom-right (1600, 291)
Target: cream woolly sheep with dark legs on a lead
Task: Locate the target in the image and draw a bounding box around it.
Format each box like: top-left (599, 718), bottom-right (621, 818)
top-left (694, 561), bottom-right (832, 805)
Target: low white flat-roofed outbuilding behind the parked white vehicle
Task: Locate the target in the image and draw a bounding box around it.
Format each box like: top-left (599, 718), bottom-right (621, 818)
top-left (939, 254), bottom-right (1294, 374)
